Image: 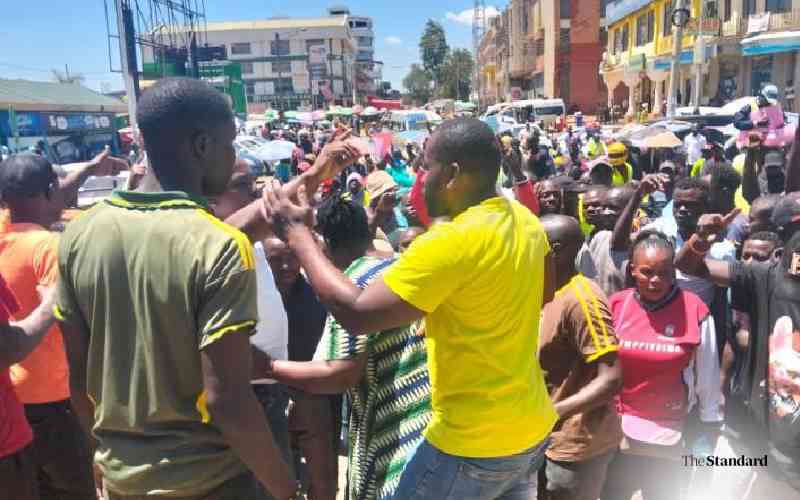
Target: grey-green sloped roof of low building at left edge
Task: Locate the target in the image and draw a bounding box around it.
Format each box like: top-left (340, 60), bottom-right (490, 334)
top-left (0, 78), bottom-right (128, 113)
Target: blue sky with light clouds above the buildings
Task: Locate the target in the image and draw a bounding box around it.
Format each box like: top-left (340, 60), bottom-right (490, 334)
top-left (0, 0), bottom-right (499, 91)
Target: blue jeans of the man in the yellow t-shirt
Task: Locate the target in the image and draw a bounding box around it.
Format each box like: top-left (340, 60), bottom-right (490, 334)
top-left (394, 439), bottom-right (549, 500)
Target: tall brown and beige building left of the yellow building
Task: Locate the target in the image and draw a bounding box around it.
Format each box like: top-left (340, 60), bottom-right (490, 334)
top-left (477, 0), bottom-right (605, 113)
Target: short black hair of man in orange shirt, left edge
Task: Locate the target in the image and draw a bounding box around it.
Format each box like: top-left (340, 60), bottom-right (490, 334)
top-left (0, 153), bottom-right (58, 201)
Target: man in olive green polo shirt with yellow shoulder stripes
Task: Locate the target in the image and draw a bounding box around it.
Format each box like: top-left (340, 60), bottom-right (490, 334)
top-left (56, 78), bottom-right (300, 500)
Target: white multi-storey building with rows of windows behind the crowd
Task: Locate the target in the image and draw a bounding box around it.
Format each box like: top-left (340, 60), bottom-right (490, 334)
top-left (156, 15), bottom-right (356, 112)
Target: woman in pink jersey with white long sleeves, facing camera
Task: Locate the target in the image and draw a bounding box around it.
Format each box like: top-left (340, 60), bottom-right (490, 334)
top-left (602, 231), bottom-right (722, 500)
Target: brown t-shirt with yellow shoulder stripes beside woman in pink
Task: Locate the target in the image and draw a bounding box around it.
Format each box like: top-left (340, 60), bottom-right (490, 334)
top-left (539, 274), bottom-right (622, 462)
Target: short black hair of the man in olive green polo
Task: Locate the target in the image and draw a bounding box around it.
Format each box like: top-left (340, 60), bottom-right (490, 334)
top-left (136, 78), bottom-right (233, 164)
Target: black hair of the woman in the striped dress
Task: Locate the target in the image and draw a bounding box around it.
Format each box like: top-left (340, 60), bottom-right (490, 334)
top-left (317, 195), bottom-right (372, 251)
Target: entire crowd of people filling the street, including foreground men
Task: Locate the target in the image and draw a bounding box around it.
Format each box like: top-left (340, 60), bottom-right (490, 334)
top-left (0, 78), bottom-right (800, 500)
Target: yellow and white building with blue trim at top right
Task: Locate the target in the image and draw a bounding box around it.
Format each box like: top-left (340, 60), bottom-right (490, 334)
top-left (600, 0), bottom-right (800, 115)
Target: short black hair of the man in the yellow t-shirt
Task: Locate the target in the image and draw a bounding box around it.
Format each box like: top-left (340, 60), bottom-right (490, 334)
top-left (428, 118), bottom-right (502, 183)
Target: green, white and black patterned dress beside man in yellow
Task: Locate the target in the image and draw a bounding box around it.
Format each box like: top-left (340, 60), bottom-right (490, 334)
top-left (314, 257), bottom-right (431, 500)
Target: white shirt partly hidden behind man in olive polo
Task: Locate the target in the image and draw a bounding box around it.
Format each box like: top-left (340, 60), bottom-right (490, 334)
top-left (250, 242), bottom-right (289, 383)
